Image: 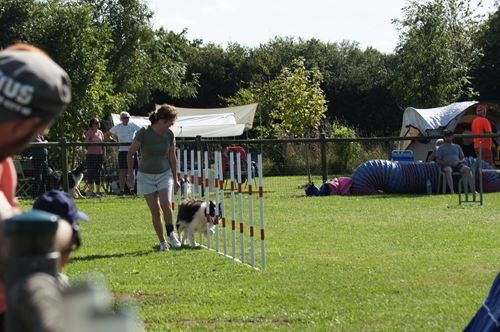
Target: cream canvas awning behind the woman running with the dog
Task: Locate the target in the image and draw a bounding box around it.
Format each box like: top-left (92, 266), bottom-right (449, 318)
top-left (111, 104), bottom-right (258, 137)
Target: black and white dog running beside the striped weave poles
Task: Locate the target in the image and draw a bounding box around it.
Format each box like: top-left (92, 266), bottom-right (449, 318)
top-left (177, 199), bottom-right (216, 248)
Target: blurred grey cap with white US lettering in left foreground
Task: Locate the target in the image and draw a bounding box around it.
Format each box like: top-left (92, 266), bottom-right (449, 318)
top-left (0, 50), bottom-right (71, 122)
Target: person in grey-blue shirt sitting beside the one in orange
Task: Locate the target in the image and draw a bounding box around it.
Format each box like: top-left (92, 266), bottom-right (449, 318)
top-left (436, 130), bottom-right (476, 194)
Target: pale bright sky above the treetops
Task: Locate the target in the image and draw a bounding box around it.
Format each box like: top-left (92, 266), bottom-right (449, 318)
top-left (146, 0), bottom-right (495, 52)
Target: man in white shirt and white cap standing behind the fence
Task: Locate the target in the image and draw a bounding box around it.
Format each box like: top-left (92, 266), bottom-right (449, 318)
top-left (104, 112), bottom-right (141, 195)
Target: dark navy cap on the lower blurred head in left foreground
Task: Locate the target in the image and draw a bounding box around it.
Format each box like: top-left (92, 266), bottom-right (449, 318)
top-left (33, 190), bottom-right (89, 247)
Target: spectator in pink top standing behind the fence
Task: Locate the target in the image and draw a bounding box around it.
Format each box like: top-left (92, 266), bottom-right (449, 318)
top-left (85, 118), bottom-right (105, 196)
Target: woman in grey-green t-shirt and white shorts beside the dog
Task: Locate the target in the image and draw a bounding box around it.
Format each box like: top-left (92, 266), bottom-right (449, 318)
top-left (127, 104), bottom-right (181, 251)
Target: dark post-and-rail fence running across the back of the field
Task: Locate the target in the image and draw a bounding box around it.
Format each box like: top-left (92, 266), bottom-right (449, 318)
top-left (14, 134), bottom-right (500, 197)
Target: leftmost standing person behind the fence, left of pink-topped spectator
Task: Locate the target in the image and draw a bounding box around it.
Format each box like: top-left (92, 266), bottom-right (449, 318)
top-left (31, 135), bottom-right (49, 198)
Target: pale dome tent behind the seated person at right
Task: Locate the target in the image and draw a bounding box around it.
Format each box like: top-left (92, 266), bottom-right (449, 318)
top-left (399, 101), bottom-right (500, 160)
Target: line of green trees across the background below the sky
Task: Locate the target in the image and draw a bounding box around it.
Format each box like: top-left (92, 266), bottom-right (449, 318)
top-left (0, 0), bottom-right (500, 141)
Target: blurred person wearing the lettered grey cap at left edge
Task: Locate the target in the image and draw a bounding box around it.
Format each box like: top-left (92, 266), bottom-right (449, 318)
top-left (0, 44), bottom-right (71, 329)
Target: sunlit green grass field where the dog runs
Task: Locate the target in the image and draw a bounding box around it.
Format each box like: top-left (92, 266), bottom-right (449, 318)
top-left (18, 177), bottom-right (500, 331)
